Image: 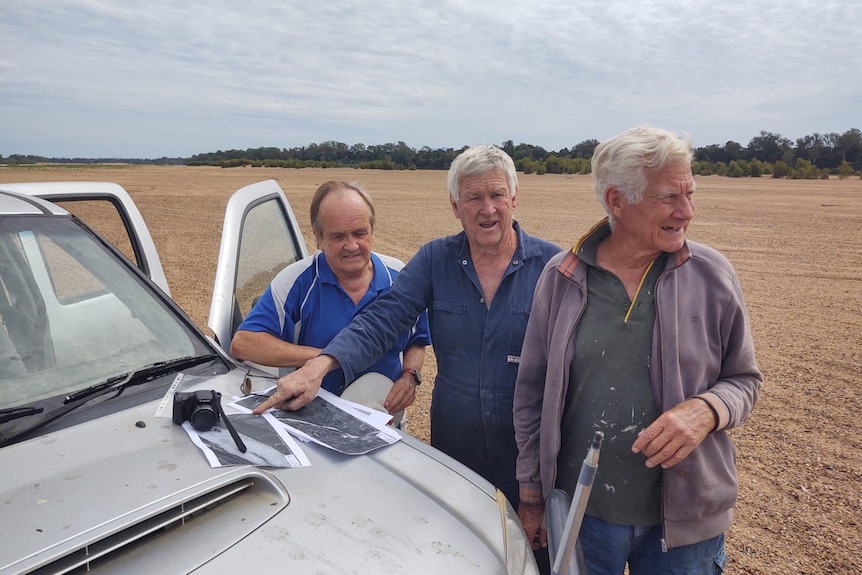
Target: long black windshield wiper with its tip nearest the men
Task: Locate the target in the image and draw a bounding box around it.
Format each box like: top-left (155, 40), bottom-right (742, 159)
top-left (0, 354), bottom-right (219, 447)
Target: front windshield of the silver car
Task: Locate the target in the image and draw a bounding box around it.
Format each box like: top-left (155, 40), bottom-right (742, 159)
top-left (0, 215), bottom-right (213, 409)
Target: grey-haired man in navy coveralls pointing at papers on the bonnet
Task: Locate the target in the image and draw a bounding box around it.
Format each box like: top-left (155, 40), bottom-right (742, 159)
top-left (255, 150), bottom-right (560, 507)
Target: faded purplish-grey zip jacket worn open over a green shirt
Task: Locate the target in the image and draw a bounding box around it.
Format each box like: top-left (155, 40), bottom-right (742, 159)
top-left (513, 219), bottom-right (763, 548)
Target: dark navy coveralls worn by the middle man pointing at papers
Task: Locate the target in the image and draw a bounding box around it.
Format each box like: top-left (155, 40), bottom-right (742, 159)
top-left (323, 222), bottom-right (560, 507)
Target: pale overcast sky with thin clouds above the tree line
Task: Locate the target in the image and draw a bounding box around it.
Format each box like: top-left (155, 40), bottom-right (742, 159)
top-left (0, 0), bottom-right (862, 158)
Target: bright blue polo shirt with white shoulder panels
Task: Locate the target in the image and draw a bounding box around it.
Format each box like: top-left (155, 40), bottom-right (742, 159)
top-left (239, 252), bottom-right (431, 395)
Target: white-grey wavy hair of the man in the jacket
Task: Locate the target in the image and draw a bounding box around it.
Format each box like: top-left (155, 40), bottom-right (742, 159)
top-left (591, 127), bottom-right (692, 225)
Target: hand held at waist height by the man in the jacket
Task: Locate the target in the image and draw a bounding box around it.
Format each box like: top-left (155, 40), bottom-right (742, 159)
top-left (632, 398), bottom-right (716, 469)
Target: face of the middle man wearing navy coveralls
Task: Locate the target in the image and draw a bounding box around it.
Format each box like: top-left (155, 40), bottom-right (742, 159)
top-left (451, 170), bottom-right (517, 253)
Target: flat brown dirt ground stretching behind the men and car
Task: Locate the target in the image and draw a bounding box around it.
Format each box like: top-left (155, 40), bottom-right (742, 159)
top-left (0, 166), bottom-right (862, 575)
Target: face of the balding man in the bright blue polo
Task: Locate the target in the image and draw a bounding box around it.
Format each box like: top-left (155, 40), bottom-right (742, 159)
top-left (315, 190), bottom-right (374, 279)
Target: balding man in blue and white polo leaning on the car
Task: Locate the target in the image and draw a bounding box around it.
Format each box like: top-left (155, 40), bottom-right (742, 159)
top-left (231, 181), bottom-right (431, 420)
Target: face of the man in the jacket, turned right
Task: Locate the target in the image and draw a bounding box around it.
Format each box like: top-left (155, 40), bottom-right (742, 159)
top-left (614, 162), bottom-right (695, 255)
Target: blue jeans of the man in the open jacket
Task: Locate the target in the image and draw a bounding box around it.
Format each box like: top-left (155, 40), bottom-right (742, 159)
top-left (578, 515), bottom-right (727, 575)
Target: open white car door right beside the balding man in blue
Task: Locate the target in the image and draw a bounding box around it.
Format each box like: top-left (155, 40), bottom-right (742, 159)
top-left (208, 180), bottom-right (308, 360)
